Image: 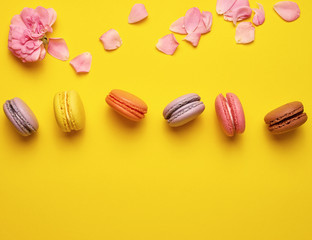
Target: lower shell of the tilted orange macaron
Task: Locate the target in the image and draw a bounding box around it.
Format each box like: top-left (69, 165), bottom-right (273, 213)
top-left (105, 95), bottom-right (144, 122)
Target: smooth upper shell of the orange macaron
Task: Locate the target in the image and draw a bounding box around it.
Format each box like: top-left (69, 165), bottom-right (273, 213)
top-left (109, 89), bottom-right (147, 114)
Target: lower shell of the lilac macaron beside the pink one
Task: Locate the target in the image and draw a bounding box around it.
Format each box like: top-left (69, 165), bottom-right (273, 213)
top-left (168, 101), bottom-right (205, 127)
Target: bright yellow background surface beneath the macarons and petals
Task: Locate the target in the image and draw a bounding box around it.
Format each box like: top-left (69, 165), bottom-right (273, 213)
top-left (0, 0), bottom-right (312, 240)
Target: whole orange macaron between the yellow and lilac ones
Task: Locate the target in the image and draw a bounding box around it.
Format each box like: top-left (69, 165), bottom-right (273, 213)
top-left (105, 89), bottom-right (147, 122)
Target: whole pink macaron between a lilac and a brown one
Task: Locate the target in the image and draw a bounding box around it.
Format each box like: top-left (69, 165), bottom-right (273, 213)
top-left (215, 93), bottom-right (245, 137)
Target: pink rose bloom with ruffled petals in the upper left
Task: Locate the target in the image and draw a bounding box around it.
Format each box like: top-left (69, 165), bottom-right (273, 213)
top-left (8, 7), bottom-right (56, 62)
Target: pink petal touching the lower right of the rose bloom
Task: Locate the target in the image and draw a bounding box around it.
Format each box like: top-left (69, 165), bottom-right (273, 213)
top-left (48, 38), bottom-right (69, 61)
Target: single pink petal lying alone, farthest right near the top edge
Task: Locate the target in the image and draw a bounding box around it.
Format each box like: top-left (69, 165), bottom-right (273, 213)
top-left (273, 1), bottom-right (300, 22)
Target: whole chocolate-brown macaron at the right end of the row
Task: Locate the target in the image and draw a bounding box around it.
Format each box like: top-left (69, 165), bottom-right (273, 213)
top-left (264, 101), bottom-right (308, 134)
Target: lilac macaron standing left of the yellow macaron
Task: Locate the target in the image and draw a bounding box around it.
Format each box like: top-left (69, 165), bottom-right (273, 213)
top-left (3, 97), bottom-right (39, 136)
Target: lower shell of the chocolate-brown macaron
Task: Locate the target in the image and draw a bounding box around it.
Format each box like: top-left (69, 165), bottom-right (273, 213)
top-left (268, 113), bottom-right (308, 134)
